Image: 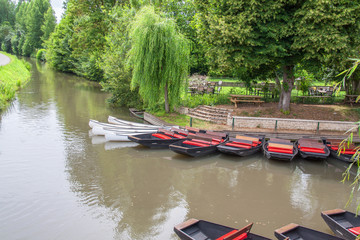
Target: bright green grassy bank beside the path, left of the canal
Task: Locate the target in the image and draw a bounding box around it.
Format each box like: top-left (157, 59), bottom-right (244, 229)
top-left (0, 52), bottom-right (30, 110)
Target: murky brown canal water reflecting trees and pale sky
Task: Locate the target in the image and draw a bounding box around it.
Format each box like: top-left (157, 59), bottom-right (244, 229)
top-left (0, 62), bottom-right (356, 240)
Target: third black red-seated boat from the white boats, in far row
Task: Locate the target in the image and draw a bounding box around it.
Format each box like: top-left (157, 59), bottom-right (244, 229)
top-left (217, 135), bottom-right (265, 157)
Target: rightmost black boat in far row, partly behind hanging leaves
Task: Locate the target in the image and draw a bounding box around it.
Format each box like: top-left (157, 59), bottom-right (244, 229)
top-left (323, 139), bottom-right (358, 163)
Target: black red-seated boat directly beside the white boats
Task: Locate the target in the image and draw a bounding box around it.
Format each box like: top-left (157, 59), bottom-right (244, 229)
top-left (128, 129), bottom-right (188, 148)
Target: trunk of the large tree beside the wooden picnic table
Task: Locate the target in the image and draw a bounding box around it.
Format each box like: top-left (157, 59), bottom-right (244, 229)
top-left (279, 65), bottom-right (295, 113)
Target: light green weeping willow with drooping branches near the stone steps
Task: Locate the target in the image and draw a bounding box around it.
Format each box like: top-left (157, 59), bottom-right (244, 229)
top-left (129, 6), bottom-right (190, 112)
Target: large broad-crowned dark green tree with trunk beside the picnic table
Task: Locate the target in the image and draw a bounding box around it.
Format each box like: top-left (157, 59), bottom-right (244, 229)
top-left (195, 0), bottom-right (360, 112)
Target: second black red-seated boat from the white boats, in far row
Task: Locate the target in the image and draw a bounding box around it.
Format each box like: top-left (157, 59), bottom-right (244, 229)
top-left (169, 131), bottom-right (228, 157)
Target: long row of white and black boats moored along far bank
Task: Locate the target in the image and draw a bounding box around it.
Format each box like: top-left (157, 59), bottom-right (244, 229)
top-left (89, 116), bottom-right (360, 162)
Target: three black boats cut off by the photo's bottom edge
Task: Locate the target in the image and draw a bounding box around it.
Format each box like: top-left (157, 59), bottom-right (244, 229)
top-left (174, 209), bottom-right (360, 240)
